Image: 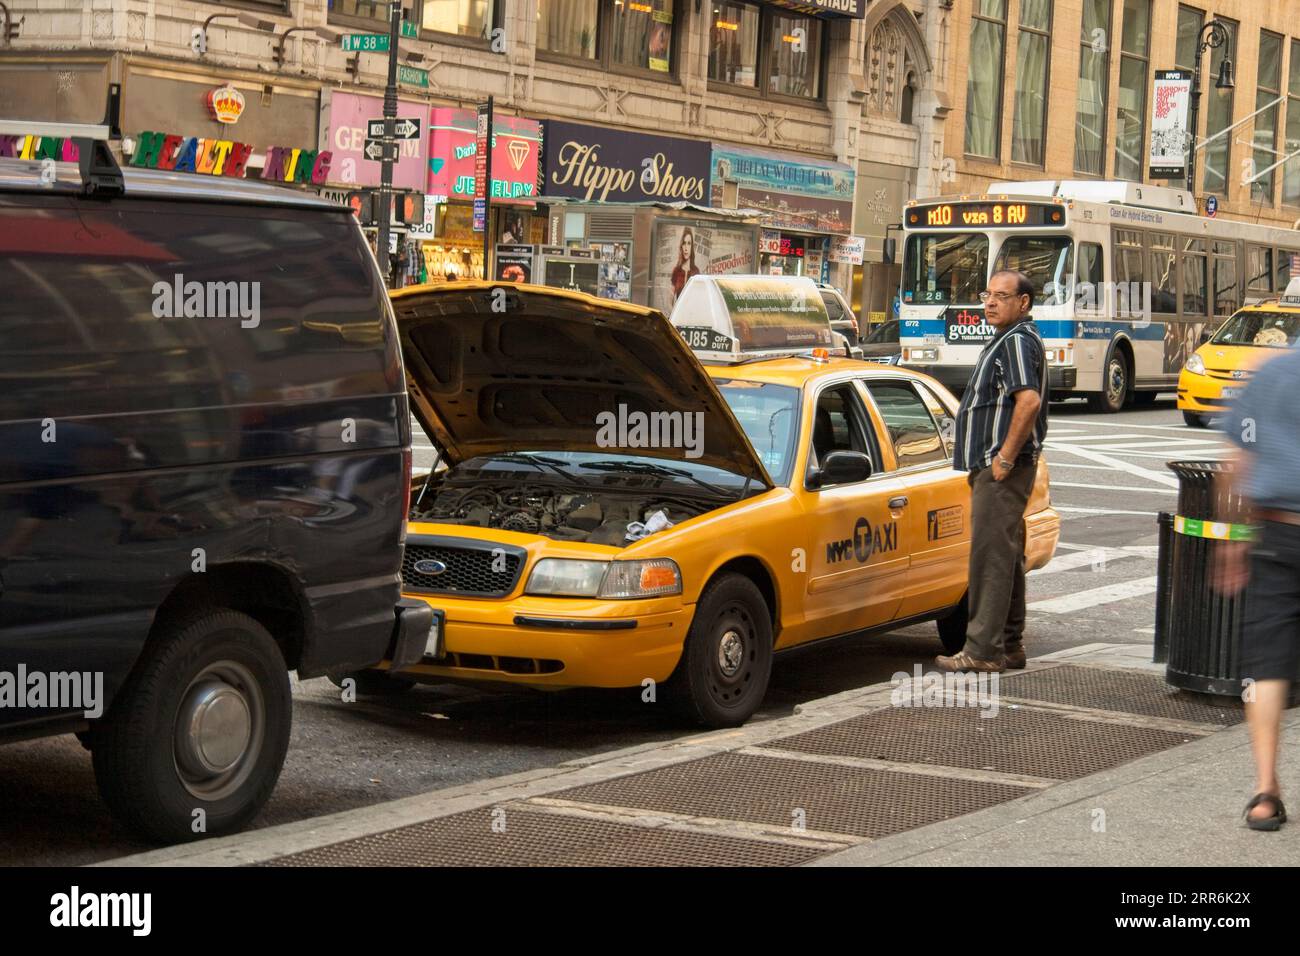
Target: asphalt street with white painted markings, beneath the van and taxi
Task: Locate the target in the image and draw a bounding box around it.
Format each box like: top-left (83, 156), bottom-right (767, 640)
top-left (0, 397), bottom-right (1226, 865)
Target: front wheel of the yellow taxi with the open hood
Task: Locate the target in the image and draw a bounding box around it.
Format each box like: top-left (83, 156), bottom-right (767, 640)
top-left (670, 575), bottom-right (772, 727)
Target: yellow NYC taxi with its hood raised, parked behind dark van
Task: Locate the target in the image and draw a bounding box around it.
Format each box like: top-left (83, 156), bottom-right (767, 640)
top-left (369, 282), bottom-right (1060, 726)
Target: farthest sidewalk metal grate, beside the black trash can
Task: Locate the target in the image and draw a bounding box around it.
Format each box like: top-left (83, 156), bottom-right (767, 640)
top-left (1001, 663), bottom-right (1244, 727)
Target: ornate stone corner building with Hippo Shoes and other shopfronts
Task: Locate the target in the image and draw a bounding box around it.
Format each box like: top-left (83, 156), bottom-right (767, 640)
top-left (0, 0), bottom-right (950, 317)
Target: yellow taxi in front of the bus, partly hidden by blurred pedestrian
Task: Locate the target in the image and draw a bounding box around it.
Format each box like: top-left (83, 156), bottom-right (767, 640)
top-left (1178, 278), bottom-right (1300, 428)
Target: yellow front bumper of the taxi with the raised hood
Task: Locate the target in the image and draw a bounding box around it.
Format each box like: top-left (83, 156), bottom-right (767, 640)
top-left (380, 594), bottom-right (694, 689)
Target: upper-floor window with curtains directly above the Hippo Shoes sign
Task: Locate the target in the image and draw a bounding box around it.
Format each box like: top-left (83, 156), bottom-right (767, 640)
top-left (537, 0), bottom-right (675, 73)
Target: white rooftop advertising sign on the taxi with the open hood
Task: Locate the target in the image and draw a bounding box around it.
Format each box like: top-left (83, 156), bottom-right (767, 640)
top-left (670, 276), bottom-right (832, 362)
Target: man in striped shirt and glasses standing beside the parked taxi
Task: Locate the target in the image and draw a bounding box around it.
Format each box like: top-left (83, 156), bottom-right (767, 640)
top-left (935, 271), bottom-right (1048, 671)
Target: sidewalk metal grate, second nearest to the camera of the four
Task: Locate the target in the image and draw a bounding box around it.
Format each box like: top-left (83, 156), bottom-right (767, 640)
top-left (550, 753), bottom-right (1031, 838)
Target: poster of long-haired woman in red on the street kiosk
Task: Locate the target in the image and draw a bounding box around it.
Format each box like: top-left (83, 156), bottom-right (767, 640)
top-left (650, 221), bottom-right (757, 315)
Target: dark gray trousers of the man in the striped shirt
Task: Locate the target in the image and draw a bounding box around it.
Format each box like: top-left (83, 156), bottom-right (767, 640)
top-left (965, 462), bottom-right (1036, 661)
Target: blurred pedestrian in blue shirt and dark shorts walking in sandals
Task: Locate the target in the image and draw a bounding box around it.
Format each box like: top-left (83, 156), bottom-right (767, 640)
top-left (1214, 346), bottom-right (1300, 830)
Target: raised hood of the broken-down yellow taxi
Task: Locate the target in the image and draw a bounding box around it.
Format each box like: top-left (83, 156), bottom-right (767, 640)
top-left (391, 281), bottom-right (772, 488)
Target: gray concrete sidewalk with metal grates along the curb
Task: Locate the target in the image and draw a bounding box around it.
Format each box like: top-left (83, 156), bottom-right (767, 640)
top-left (101, 644), bottom-right (1300, 866)
